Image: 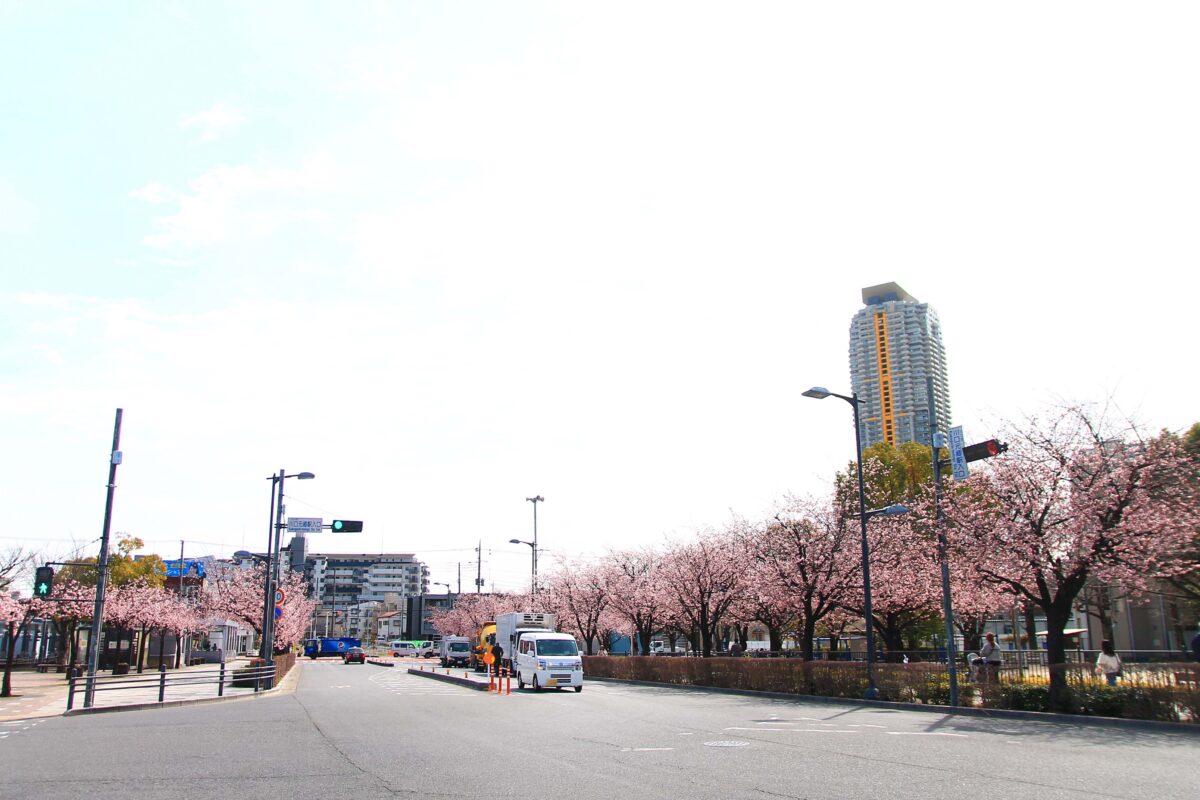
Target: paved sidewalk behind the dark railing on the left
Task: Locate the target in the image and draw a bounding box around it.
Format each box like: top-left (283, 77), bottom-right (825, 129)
top-left (0, 658), bottom-right (270, 722)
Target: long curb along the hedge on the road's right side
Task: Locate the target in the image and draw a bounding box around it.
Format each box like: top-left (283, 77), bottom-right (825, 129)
top-left (587, 675), bottom-right (1200, 736)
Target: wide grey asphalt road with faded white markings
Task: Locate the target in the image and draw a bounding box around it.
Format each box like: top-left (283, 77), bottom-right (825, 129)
top-left (0, 661), bottom-right (1200, 800)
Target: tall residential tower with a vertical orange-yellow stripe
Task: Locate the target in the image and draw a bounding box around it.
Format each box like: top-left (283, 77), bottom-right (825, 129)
top-left (850, 283), bottom-right (950, 449)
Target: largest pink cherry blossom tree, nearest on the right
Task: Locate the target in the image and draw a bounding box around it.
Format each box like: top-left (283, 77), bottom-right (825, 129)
top-left (946, 408), bottom-right (1200, 708)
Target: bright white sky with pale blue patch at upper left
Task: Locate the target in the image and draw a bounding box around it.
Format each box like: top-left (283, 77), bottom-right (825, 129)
top-left (0, 0), bottom-right (1200, 590)
